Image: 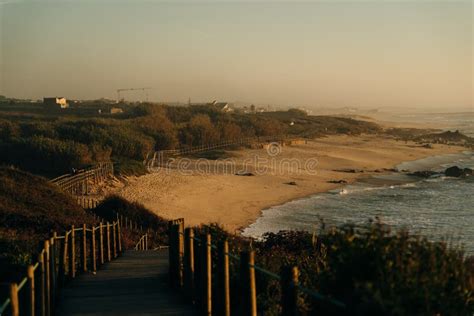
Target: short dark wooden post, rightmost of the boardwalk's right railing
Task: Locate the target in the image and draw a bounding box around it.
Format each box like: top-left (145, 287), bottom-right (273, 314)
top-left (281, 266), bottom-right (299, 316)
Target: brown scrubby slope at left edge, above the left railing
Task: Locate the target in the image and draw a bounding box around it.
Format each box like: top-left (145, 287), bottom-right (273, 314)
top-left (0, 167), bottom-right (94, 286)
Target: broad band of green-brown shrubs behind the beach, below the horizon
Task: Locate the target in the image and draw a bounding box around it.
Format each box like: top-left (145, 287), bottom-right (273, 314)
top-left (0, 103), bottom-right (381, 177)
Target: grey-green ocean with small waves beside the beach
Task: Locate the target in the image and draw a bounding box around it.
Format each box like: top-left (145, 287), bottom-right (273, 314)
top-left (243, 151), bottom-right (474, 255)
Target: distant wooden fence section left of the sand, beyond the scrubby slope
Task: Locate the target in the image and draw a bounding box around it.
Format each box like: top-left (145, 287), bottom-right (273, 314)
top-left (50, 162), bottom-right (114, 195)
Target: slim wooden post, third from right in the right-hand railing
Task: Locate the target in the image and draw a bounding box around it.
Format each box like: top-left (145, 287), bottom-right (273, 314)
top-left (217, 240), bottom-right (230, 316)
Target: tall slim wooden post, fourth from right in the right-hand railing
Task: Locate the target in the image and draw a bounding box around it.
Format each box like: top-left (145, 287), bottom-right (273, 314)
top-left (201, 233), bottom-right (211, 315)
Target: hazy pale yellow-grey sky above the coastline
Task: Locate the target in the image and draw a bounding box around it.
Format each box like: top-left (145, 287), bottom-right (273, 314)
top-left (0, 0), bottom-right (473, 108)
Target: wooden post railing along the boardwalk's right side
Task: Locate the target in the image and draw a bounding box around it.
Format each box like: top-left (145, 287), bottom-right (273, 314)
top-left (169, 219), bottom-right (346, 316)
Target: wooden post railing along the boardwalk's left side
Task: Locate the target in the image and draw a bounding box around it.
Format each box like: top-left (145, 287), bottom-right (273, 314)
top-left (0, 220), bottom-right (122, 316)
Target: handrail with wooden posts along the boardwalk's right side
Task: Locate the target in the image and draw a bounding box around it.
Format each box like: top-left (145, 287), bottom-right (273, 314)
top-left (169, 219), bottom-right (347, 315)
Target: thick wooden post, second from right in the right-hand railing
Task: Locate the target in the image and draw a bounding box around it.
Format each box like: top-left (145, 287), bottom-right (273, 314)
top-left (240, 251), bottom-right (257, 316)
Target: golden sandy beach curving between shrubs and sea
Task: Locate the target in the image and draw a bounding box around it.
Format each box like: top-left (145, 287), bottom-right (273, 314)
top-left (114, 135), bottom-right (465, 232)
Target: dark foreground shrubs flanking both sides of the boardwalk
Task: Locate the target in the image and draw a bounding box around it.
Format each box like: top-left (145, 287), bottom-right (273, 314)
top-left (0, 168), bottom-right (474, 315)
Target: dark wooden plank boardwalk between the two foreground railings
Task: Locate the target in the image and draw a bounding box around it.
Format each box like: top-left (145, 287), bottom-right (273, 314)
top-left (56, 250), bottom-right (197, 316)
